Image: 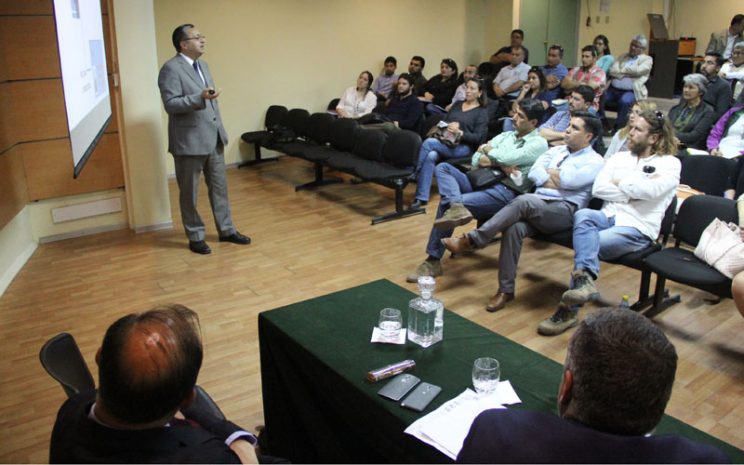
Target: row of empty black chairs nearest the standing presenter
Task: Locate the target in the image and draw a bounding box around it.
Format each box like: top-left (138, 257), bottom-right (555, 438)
top-left (241, 105), bottom-right (425, 224)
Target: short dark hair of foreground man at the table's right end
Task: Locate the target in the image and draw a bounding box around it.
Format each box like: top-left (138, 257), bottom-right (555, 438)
top-left (566, 309), bottom-right (677, 436)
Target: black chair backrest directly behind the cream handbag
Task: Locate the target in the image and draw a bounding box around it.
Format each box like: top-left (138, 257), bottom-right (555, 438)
top-left (674, 195), bottom-right (739, 246)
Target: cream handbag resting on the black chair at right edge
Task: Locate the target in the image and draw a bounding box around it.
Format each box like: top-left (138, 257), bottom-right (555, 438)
top-left (695, 218), bottom-right (744, 279)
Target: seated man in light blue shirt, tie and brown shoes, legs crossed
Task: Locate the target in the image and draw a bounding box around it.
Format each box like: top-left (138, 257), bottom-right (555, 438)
top-left (442, 112), bottom-right (604, 312)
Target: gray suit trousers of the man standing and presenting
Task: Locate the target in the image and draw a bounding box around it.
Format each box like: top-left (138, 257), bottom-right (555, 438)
top-left (173, 142), bottom-right (235, 241)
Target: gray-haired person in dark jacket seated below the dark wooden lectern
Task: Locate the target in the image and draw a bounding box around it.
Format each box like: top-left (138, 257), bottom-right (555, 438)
top-left (669, 74), bottom-right (716, 150)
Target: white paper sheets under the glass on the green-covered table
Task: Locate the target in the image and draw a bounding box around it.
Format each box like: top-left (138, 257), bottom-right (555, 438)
top-left (405, 381), bottom-right (522, 460)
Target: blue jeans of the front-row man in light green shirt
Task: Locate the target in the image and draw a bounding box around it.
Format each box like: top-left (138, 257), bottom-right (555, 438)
top-left (426, 163), bottom-right (517, 258)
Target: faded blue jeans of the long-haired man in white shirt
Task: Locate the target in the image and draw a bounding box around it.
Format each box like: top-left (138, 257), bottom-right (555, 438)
top-left (573, 208), bottom-right (651, 279)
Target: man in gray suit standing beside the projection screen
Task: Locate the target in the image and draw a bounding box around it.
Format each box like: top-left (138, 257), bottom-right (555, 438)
top-left (158, 24), bottom-right (251, 254)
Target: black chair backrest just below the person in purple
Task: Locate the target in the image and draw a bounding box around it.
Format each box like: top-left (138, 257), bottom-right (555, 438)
top-left (679, 155), bottom-right (736, 197)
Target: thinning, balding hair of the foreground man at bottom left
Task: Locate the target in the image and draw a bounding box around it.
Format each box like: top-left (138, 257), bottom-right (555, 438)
top-left (98, 304), bottom-right (203, 424)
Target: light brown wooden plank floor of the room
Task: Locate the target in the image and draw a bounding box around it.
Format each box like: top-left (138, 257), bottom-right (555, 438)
top-left (0, 158), bottom-right (744, 462)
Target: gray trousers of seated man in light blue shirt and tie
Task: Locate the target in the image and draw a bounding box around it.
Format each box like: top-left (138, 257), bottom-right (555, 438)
top-left (468, 194), bottom-right (576, 293)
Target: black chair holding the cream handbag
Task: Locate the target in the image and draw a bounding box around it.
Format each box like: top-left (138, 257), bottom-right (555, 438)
top-left (645, 195), bottom-right (738, 317)
